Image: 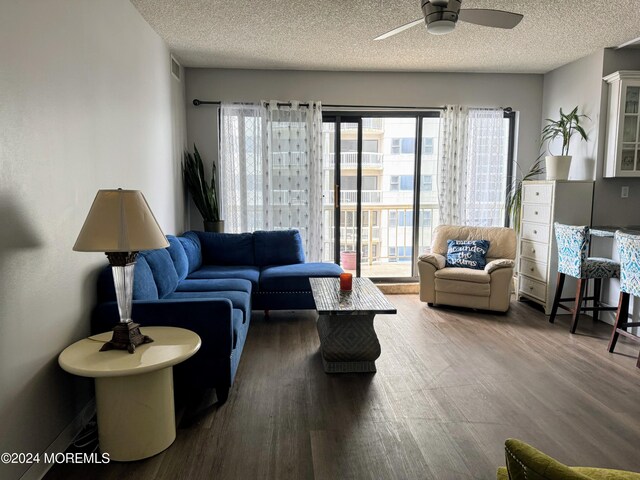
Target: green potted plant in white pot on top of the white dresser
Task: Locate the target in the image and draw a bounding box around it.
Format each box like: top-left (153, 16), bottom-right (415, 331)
top-left (542, 106), bottom-right (589, 180)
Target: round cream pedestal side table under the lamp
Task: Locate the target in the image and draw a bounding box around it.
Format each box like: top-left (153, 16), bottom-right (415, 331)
top-left (58, 327), bottom-right (201, 462)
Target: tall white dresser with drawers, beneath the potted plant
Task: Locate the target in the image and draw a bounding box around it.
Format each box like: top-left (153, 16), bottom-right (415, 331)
top-left (518, 180), bottom-right (593, 315)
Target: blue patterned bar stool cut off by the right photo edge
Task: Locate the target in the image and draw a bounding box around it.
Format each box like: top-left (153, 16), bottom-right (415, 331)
top-left (609, 231), bottom-right (640, 368)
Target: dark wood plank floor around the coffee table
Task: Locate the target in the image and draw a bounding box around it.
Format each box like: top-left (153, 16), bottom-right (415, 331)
top-left (46, 295), bottom-right (640, 480)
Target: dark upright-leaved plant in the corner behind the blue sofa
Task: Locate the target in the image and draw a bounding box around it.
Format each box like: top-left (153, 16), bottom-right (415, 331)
top-left (182, 144), bottom-right (224, 232)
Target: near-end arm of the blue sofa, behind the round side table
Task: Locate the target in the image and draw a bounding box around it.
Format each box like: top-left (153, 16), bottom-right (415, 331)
top-left (91, 298), bottom-right (233, 358)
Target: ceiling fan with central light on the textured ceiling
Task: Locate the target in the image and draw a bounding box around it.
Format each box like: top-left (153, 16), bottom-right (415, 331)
top-left (374, 0), bottom-right (523, 40)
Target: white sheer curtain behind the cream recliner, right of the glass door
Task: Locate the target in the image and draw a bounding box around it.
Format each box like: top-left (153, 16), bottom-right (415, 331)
top-left (438, 105), bottom-right (508, 226)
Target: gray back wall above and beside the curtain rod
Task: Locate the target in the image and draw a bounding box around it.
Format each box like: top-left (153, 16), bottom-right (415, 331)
top-left (186, 68), bottom-right (542, 229)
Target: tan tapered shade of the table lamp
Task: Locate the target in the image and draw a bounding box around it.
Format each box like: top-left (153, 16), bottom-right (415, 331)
top-left (73, 189), bottom-right (169, 252)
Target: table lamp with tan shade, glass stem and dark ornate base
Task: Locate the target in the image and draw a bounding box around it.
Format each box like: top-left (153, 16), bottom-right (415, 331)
top-left (73, 188), bottom-right (169, 353)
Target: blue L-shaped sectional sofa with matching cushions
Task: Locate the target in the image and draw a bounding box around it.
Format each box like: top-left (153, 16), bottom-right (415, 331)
top-left (91, 230), bottom-right (342, 403)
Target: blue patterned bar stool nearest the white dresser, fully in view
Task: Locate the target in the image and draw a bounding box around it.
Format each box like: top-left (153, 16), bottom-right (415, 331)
top-left (549, 222), bottom-right (620, 333)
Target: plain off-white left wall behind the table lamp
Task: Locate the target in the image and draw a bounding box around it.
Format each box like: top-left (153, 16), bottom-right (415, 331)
top-left (0, 0), bottom-right (185, 479)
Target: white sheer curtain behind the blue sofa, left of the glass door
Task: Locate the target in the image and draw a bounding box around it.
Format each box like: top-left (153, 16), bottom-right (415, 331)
top-left (219, 100), bottom-right (324, 261)
